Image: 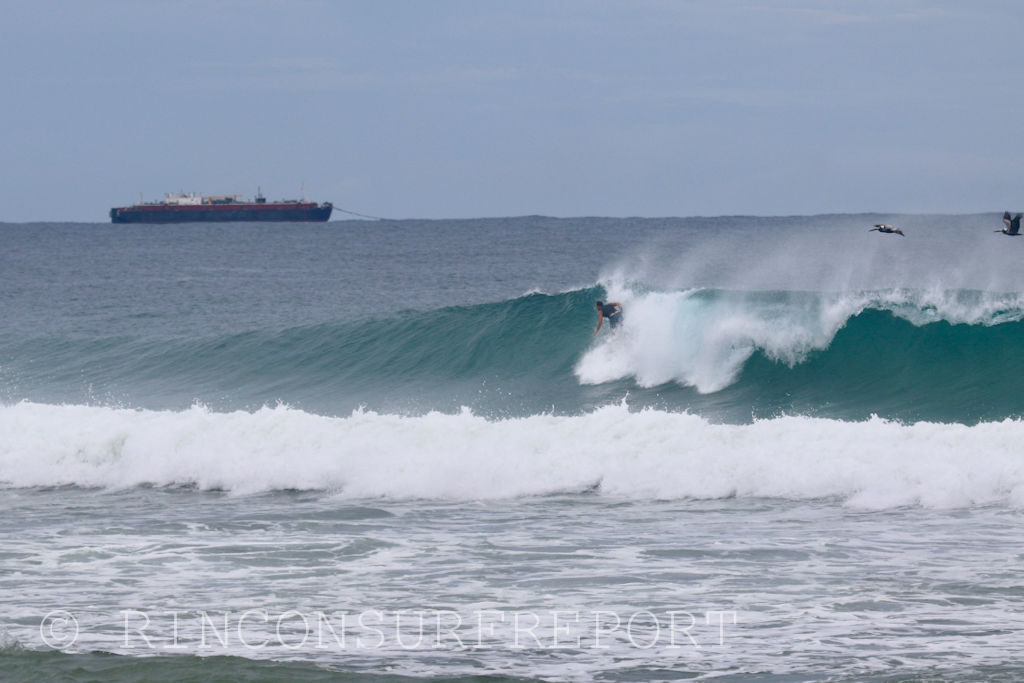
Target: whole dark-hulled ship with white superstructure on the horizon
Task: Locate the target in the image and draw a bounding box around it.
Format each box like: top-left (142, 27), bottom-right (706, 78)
top-left (111, 191), bottom-right (334, 223)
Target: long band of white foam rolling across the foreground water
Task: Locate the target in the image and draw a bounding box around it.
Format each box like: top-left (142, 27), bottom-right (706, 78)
top-left (0, 402), bottom-right (1024, 508)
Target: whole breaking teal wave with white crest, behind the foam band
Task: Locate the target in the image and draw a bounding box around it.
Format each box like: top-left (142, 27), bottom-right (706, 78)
top-left (6, 284), bottom-right (1024, 424)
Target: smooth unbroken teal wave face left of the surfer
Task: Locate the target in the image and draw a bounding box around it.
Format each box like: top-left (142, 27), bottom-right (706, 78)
top-left (0, 290), bottom-right (597, 413)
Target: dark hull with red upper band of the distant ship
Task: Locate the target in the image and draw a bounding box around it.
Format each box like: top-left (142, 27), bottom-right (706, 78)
top-left (111, 203), bottom-right (334, 223)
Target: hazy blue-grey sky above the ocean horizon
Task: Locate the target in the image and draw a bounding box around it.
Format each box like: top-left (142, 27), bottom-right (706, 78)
top-left (0, 0), bottom-right (1024, 222)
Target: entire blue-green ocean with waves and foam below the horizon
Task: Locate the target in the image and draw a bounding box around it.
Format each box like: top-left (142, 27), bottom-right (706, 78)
top-left (0, 213), bottom-right (1024, 683)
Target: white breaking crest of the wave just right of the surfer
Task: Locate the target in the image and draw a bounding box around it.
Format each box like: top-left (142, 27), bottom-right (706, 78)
top-left (575, 283), bottom-right (1024, 393)
